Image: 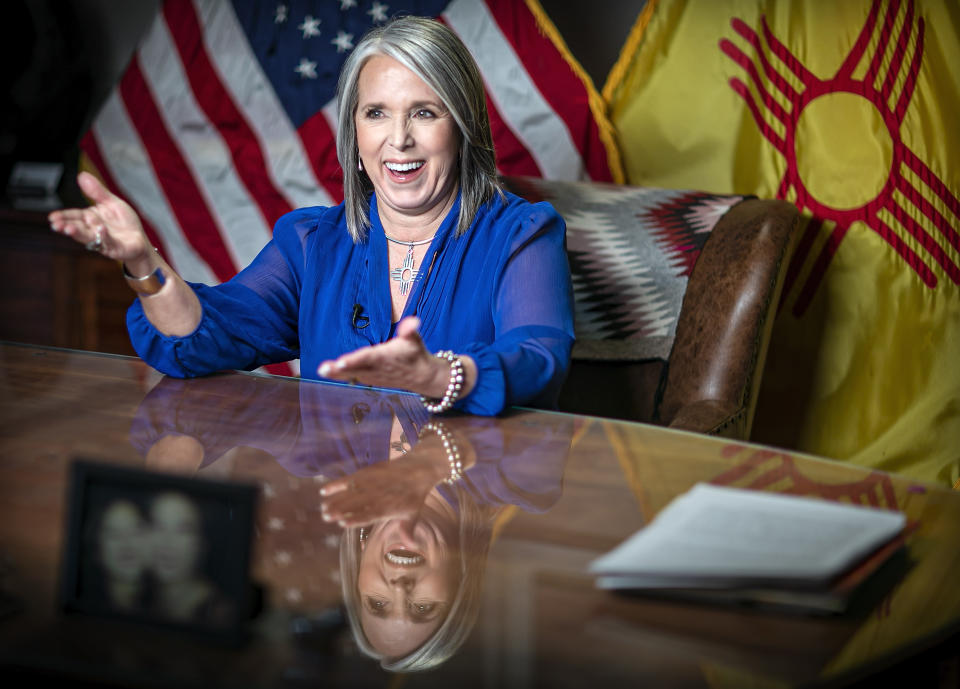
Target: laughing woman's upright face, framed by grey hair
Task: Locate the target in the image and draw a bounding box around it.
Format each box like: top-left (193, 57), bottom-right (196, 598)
top-left (354, 55), bottom-right (460, 229)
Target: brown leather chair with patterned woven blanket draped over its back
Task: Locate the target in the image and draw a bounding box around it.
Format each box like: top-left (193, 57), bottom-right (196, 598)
top-left (505, 178), bottom-right (799, 440)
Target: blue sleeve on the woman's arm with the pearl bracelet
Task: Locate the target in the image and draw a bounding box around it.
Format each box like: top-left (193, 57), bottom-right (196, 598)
top-left (456, 203), bottom-right (574, 415)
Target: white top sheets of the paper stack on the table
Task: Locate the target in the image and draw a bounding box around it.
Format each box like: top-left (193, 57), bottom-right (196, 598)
top-left (590, 484), bottom-right (906, 586)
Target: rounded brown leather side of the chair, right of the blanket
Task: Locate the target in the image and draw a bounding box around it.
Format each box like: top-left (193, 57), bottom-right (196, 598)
top-left (657, 199), bottom-right (800, 440)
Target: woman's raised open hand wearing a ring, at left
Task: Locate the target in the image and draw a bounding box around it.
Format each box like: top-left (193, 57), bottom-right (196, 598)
top-left (47, 172), bottom-right (152, 268)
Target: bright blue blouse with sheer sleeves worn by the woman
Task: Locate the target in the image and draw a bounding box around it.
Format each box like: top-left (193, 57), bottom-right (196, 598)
top-left (127, 189), bottom-right (573, 415)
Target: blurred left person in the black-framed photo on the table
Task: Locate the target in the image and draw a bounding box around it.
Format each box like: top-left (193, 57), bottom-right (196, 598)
top-left (83, 498), bottom-right (149, 612)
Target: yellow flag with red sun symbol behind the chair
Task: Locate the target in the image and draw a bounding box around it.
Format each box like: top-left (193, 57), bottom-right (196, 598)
top-left (603, 0), bottom-right (960, 486)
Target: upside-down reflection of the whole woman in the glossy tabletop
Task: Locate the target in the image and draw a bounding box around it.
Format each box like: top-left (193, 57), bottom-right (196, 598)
top-left (131, 375), bottom-right (573, 671)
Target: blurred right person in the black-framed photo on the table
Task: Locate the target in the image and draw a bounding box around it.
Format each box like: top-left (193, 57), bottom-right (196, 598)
top-left (150, 492), bottom-right (230, 624)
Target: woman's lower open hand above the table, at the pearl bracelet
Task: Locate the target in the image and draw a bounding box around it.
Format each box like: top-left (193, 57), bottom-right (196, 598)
top-left (317, 316), bottom-right (476, 398)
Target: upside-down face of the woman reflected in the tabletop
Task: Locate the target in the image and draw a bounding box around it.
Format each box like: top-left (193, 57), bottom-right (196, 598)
top-left (357, 519), bottom-right (458, 658)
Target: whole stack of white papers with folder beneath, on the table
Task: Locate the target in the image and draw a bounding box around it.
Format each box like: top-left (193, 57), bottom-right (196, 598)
top-left (590, 483), bottom-right (906, 612)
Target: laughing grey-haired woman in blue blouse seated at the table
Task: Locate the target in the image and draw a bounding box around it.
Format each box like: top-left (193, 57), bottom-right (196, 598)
top-left (50, 17), bottom-right (573, 414)
